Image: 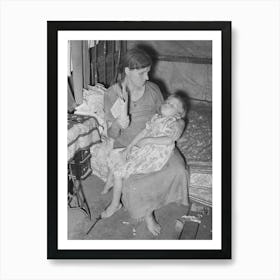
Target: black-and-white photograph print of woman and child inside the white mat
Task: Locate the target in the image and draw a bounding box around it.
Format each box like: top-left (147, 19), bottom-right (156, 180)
top-left (67, 41), bottom-right (212, 239)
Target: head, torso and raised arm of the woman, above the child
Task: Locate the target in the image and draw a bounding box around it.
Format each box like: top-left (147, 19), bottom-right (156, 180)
top-left (105, 49), bottom-right (163, 147)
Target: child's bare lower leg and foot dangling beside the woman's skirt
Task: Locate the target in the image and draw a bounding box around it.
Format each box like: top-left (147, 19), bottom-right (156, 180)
top-left (101, 176), bottom-right (122, 218)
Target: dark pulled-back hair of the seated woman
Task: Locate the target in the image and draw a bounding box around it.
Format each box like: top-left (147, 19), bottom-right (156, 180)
top-left (120, 48), bottom-right (152, 72)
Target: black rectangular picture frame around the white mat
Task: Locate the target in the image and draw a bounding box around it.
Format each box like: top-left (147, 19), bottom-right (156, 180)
top-left (47, 21), bottom-right (231, 259)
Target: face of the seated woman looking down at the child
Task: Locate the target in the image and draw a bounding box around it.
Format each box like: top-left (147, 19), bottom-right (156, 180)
top-left (125, 66), bottom-right (151, 88)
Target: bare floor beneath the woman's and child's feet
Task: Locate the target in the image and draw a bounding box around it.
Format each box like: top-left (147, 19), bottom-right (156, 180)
top-left (68, 175), bottom-right (212, 240)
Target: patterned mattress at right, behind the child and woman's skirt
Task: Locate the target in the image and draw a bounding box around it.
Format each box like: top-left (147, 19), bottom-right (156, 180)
top-left (177, 103), bottom-right (212, 206)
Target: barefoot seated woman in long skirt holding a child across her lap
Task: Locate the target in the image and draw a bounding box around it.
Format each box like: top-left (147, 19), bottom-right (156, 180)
top-left (105, 49), bottom-right (188, 235)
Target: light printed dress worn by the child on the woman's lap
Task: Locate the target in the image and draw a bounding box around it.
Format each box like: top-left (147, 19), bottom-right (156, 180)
top-left (108, 114), bottom-right (183, 178)
